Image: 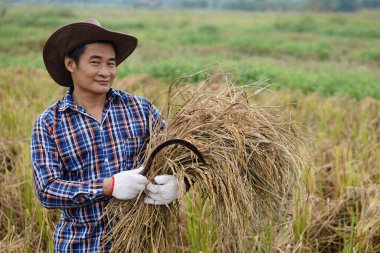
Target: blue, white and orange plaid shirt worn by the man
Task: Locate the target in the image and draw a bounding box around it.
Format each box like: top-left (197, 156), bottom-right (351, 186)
top-left (31, 89), bottom-right (160, 252)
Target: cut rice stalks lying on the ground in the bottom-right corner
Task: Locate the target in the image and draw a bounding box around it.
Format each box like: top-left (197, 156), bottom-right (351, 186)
top-left (305, 185), bottom-right (380, 252)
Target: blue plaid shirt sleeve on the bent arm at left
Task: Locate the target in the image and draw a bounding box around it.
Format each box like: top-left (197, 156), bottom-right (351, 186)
top-left (31, 117), bottom-right (104, 209)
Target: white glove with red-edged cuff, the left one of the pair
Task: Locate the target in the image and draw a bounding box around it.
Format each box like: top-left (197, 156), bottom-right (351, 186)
top-left (111, 167), bottom-right (149, 200)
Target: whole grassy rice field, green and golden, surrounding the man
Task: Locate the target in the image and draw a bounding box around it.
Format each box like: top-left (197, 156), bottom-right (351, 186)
top-left (0, 5), bottom-right (380, 252)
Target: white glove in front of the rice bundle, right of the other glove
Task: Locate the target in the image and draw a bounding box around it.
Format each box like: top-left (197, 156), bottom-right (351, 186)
top-left (144, 175), bottom-right (179, 205)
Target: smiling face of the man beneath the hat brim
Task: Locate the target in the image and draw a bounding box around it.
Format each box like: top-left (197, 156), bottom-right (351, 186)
top-left (65, 43), bottom-right (116, 96)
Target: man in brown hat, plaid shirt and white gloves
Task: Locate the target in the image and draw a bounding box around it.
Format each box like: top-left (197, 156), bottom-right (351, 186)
top-left (31, 19), bottom-right (178, 252)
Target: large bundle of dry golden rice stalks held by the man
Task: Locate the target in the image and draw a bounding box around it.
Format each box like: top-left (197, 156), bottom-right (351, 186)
top-left (106, 71), bottom-right (302, 252)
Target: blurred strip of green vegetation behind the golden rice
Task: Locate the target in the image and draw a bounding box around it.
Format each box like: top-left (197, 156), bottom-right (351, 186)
top-left (0, 6), bottom-right (380, 99)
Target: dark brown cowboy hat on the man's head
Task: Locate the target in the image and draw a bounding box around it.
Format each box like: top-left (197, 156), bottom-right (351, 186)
top-left (43, 18), bottom-right (137, 87)
